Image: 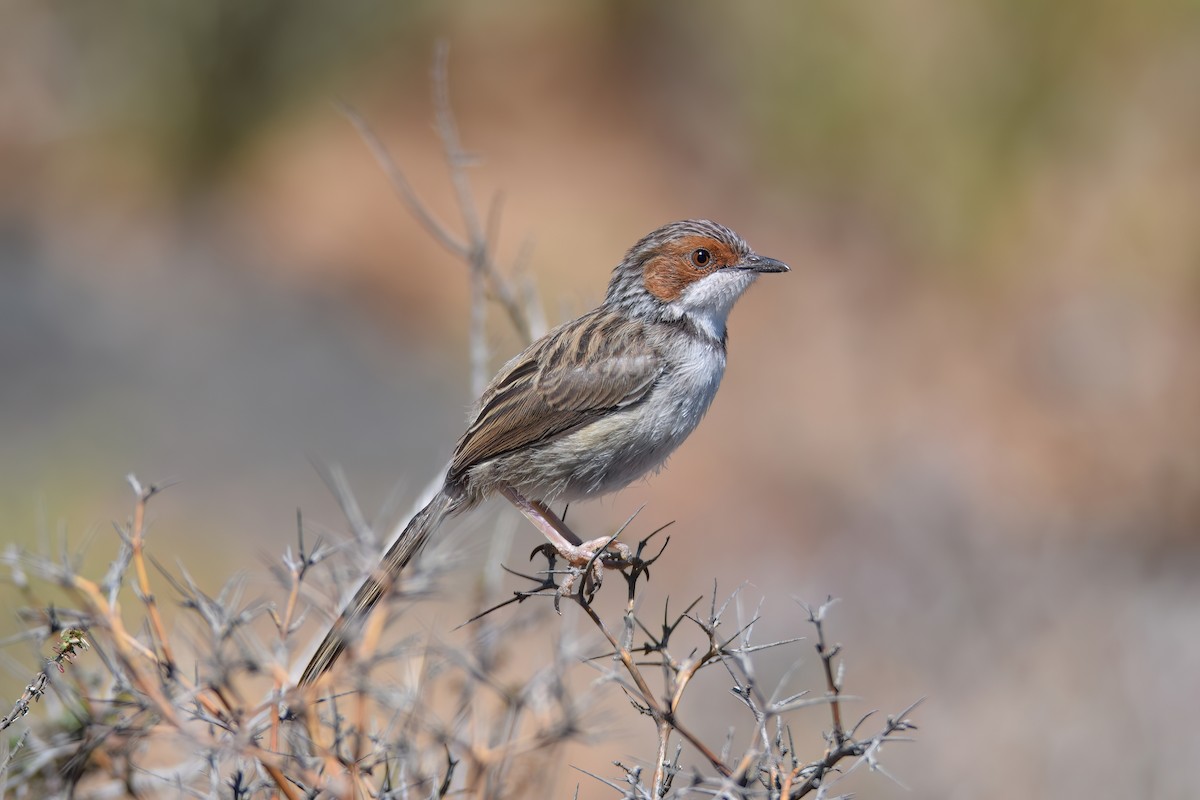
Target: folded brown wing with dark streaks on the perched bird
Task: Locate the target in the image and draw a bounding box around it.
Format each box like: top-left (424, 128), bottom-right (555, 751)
top-left (446, 309), bottom-right (662, 482)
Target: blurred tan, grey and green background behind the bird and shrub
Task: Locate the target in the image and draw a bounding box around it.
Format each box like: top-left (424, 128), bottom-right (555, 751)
top-left (0, 0), bottom-right (1200, 798)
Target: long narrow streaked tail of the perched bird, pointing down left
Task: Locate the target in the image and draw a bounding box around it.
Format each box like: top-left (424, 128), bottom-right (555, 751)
top-left (300, 492), bottom-right (457, 686)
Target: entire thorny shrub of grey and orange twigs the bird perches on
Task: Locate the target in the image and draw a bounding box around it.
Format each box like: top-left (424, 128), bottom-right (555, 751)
top-left (0, 474), bottom-right (916, 800)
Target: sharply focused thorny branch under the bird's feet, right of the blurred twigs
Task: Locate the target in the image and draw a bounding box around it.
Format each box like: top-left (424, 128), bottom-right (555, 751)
top-left (473, 537), bottom-right (919, 800)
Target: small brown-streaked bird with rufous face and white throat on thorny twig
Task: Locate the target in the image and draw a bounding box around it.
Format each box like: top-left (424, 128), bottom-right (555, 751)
top-left (299, 219), bottom-right (790, 686)
